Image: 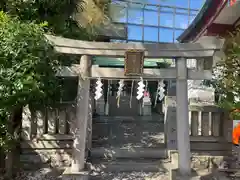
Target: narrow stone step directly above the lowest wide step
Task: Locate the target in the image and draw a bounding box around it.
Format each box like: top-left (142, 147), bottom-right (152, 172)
top-left (91, 147), bottom-right (168, 159)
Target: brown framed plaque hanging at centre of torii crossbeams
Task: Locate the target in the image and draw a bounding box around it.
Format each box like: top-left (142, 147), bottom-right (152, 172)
top-left (124, 50), bottom-right (144, 76)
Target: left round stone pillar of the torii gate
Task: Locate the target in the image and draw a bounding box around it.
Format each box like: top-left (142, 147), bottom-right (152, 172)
top-left (71, 55), bottom-right (91, 172)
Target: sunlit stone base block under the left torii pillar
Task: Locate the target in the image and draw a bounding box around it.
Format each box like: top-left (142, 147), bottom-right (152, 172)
top-left (62, 167), bottom-right (89, 180)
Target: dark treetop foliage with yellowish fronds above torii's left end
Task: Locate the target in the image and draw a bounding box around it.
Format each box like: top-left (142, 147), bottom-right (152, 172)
top-left (0, 0), bottom-right (108, 40)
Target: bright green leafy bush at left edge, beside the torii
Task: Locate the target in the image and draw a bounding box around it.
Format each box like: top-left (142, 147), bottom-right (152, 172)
top-left (0, 12), bottom-right (59, 148)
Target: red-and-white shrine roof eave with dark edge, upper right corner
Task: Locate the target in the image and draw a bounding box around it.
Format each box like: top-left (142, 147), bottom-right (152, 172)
top-left (178, 0), bottom-right (240, 43)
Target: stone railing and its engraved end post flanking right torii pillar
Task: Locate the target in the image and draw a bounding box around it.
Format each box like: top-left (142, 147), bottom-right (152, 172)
top-left (164, 97), bottom-right (232, 151)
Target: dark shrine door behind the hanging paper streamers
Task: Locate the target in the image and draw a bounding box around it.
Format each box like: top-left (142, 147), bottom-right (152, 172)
top-left (108, 81), bottom-right (140, 116)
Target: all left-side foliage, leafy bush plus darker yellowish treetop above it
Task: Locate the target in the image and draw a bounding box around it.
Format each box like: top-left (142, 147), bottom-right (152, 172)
top-left (0, 0), bottom-right (114, 153)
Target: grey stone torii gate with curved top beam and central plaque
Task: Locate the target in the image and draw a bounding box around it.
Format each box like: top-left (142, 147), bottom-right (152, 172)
top-left (21, 35), bottom-right (224, 179)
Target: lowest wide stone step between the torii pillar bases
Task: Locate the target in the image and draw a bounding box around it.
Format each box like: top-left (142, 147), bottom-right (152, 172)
top-left (87, 159), bottom-right (170, 173)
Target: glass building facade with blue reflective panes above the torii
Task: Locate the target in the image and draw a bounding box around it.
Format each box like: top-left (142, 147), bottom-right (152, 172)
top-left (111, 0), bottom-right (205, 42)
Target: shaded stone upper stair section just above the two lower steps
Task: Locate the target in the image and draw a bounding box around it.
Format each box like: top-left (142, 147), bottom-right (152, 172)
top-left (92, 121), bottom-right (165, 148)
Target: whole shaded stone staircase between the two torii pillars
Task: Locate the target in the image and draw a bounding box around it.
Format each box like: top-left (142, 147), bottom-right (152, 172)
top-left (87, 115), bottom-right (170, 180)
